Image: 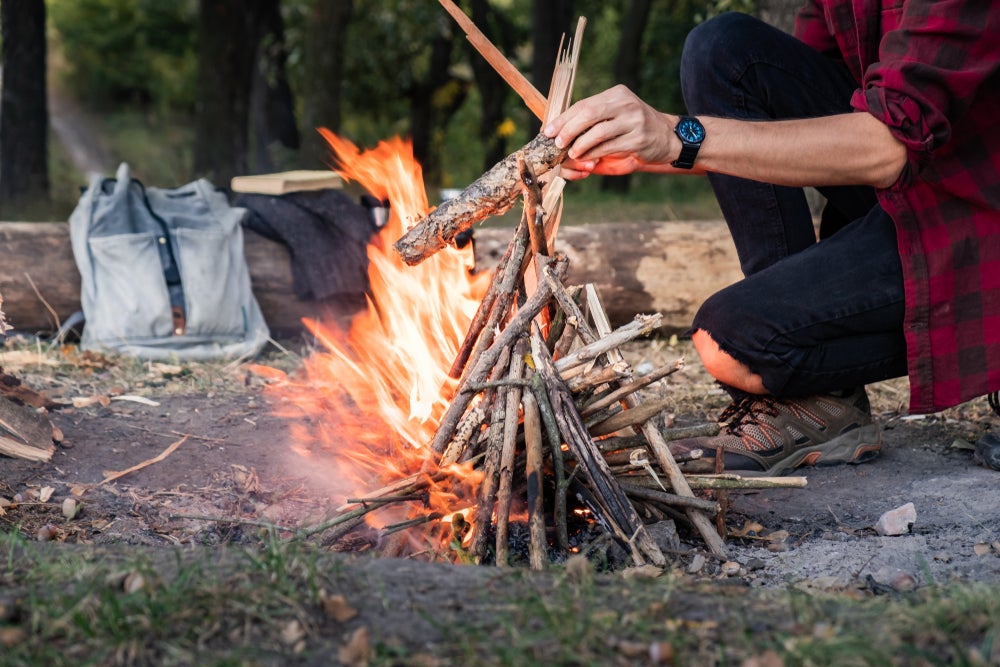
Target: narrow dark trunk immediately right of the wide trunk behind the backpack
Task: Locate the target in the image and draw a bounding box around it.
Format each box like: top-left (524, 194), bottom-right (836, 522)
top-left (250, 0), bottom-right (299, 173)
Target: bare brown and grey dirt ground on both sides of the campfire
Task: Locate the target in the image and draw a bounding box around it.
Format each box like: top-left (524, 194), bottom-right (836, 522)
top-left (0, 343), bottom-right (1000, 590)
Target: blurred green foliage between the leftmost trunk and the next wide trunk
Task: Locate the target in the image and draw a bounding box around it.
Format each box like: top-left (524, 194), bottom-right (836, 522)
top-left (48, 0), bottom-right (197, 109)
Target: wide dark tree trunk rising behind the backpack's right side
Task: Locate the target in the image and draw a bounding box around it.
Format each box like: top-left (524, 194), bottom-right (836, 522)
top-left (194, 0), bottom-right (260, 188)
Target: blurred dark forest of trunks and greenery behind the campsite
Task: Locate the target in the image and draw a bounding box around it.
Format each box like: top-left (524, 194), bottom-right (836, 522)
top-left (0, 0), bottom-right (799, 220)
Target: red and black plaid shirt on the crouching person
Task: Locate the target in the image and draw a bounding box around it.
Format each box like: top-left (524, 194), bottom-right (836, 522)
top-left (795, 0), bottom-right (1000, 412)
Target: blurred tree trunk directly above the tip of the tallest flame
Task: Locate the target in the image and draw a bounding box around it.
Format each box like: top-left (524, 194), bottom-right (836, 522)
top-left (302, 0), bottom-right (354, 168)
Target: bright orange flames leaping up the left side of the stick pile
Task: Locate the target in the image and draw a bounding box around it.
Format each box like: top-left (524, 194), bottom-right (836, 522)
top-left (277, 130), bottom-right (489, 521)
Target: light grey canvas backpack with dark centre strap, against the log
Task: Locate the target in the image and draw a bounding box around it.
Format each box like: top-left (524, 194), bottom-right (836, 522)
top-left (69, 163), bottom-right (270, 360)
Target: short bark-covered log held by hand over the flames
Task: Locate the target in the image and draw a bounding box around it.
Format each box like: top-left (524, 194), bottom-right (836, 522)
top-left (393, 134), bottom-right (566, 265)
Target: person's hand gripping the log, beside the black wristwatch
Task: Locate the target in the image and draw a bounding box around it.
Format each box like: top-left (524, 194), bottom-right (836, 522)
top-left (543, 86), bottom-right (681, 180)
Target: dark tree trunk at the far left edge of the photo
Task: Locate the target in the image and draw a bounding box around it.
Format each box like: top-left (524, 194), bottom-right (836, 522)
top-left (0, 0), bottom-right (49, 209)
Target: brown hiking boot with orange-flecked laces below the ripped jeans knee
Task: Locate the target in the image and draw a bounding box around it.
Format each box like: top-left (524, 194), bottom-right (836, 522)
top-left (669, 387), bottom-right (882, 476)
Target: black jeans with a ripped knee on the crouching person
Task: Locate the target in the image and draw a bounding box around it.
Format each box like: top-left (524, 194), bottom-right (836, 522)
top-left (681, 14), bottom-right (906, 396)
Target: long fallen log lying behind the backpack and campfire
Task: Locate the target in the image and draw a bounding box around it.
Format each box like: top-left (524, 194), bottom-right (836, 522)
top-left (0, 220), bottom-right (742, 338)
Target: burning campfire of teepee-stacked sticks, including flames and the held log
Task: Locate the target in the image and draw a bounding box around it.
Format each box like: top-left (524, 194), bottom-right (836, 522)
top-left (264, 5), bottom-right (799, 568)
